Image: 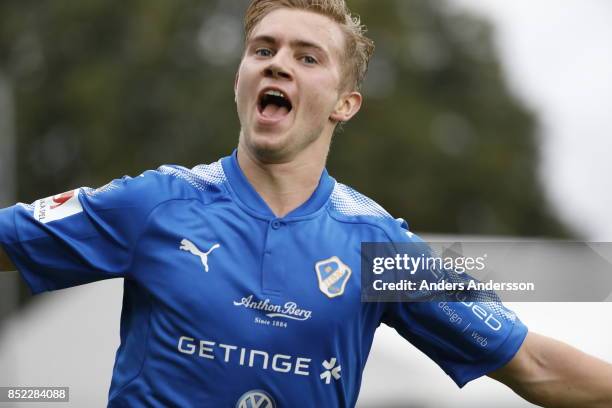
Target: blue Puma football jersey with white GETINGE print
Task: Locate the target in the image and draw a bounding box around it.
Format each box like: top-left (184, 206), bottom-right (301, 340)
top-left (0, 152), bottom-right (527, 408)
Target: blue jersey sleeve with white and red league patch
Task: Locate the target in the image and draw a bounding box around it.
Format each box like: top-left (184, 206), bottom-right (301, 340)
top-left (0, 171), bottom-right (167, 294)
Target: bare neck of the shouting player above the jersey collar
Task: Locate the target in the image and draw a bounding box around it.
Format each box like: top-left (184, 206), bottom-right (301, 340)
top-left (238, 137), bottom-right (329, 218)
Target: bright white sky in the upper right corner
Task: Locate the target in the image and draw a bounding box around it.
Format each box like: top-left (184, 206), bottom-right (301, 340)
top-left (450, 0), bottom-right (612, 241)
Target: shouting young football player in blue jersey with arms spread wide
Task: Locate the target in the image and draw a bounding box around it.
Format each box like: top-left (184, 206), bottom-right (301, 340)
top-left (0, 0), bottom-right (612, 408)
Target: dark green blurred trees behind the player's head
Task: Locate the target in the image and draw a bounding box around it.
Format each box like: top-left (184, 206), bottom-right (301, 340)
top-left (0, 0), bottom-right (568, 236)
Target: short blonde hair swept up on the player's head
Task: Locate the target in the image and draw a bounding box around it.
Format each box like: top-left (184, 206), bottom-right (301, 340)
top-left (244, 0), bottom-right (374, 90)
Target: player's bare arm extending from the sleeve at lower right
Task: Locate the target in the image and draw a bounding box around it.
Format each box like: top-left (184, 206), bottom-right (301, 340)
top-left (489, 333), bottom-right (612, 408)
